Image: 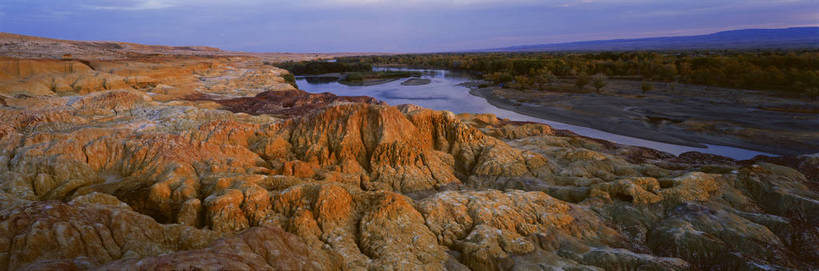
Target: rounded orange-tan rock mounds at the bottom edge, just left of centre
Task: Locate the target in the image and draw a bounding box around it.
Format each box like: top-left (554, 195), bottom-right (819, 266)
top-left (272, 183), bottom-right (449, 270)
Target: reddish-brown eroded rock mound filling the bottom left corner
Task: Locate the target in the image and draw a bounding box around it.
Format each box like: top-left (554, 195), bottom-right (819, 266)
top-left (0, 194), bottom-right (219, 270)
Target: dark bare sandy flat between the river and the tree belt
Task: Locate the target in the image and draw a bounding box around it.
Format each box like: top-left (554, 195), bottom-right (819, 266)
top-left (470, 80), bottom-right (819, 155)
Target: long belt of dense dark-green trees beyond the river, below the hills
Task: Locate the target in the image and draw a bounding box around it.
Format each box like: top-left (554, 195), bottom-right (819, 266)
top-left (334, 50), bottom-right (819, 97)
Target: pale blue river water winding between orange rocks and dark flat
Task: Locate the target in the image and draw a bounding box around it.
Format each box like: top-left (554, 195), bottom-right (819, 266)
top-left (297, 67), bottom-right (765, 159)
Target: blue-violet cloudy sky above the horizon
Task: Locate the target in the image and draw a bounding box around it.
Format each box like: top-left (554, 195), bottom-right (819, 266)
top-left (0, 0), bottom-right (819, 53)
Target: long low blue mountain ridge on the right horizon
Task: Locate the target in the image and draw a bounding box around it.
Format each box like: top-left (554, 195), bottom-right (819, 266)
top-left (477, 27), bottom-right (819, 52)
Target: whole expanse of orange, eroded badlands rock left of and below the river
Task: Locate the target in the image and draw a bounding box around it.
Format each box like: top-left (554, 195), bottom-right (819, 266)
top-left (0, 34), bottom-right (819, 270)
